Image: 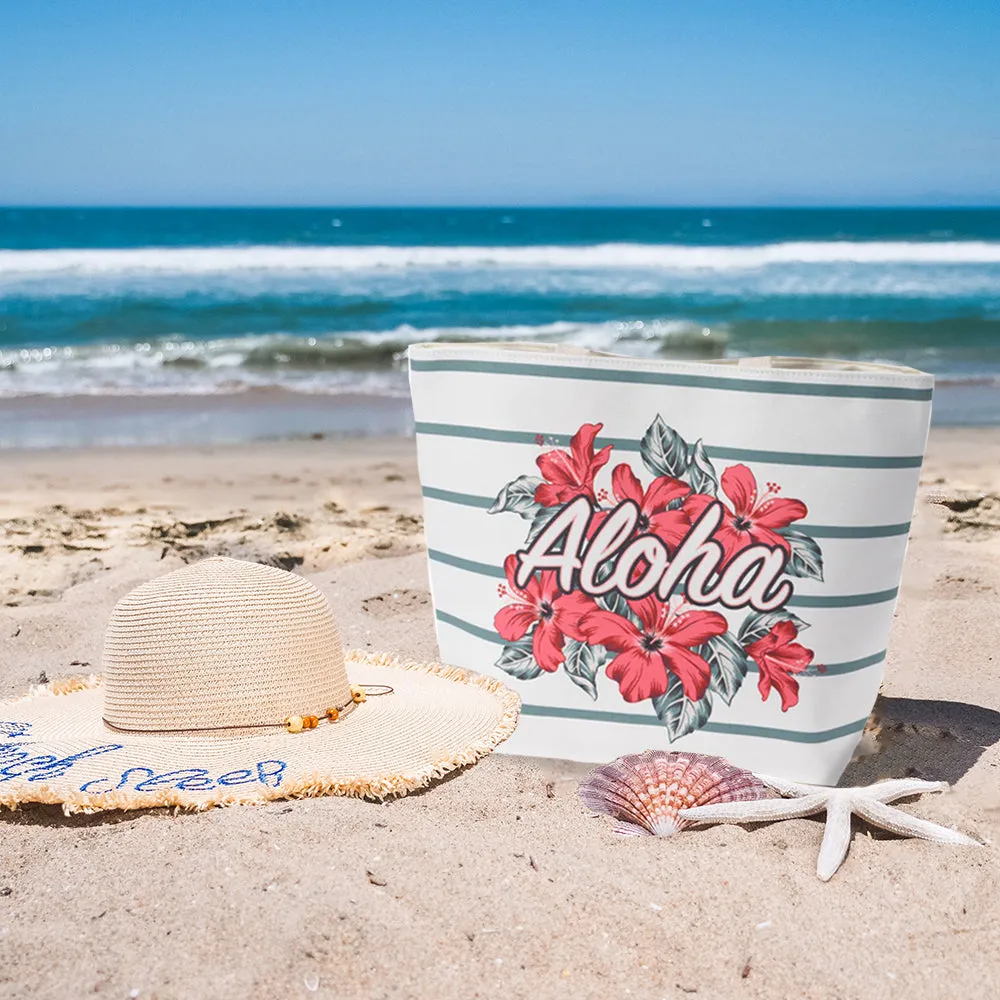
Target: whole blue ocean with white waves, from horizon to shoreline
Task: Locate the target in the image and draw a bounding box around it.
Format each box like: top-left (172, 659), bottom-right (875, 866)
top-left (0, 208), bottom-right (1000, 436)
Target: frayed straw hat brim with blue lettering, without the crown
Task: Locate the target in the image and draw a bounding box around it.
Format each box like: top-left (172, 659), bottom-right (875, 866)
top-left (0, 651), bottom-right (520, 814)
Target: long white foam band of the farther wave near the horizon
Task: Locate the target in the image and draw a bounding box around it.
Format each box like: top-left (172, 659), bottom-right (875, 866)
top-left (0, 241), bottom-right (1000, 281)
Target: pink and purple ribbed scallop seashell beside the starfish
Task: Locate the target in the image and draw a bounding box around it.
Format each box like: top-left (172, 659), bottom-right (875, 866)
top-left (579, 750), bottom-right (770, 837)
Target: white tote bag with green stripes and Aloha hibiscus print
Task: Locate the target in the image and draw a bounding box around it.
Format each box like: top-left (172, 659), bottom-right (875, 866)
top-left (409, 344), bottom-right (933, 784)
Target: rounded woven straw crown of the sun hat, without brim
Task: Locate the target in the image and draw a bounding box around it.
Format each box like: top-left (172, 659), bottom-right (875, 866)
top-left (98, 558), bottom-right (350, 732)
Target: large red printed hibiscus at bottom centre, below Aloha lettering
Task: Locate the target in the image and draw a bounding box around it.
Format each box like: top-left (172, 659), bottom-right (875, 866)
top-left (580, 595), bottom-right (728, 702)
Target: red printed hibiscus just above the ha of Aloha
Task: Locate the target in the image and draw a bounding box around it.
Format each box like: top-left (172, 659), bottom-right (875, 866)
top-left (684, 465), bottom-right (808, 562)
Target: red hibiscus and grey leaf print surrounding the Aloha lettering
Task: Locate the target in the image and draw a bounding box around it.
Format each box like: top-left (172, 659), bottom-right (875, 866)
top-left (490, 417), bottom-right (823, 740)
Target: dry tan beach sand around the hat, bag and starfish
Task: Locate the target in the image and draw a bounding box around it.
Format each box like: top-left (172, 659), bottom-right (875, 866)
top-left (0, 429), bottom-right (1000, 1000)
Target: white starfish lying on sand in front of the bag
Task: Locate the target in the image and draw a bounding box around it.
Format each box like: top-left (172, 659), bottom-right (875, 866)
top-left (677, 774), bottom-right (982, 882)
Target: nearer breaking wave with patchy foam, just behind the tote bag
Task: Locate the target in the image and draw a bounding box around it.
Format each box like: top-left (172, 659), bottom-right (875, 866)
top-left (0, 317), bottom-right (1000, 398)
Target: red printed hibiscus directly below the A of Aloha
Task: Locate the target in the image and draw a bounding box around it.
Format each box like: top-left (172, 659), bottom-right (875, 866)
top-left (493, 555), bottom-right (597, 673)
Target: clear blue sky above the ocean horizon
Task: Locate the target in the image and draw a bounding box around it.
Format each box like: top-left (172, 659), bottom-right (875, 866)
top-left (0, 0), bottom-right (1000, 205)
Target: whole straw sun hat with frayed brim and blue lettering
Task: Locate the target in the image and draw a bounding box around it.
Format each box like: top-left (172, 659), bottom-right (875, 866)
top-left (0, 559), bottom-right (520, 813)
